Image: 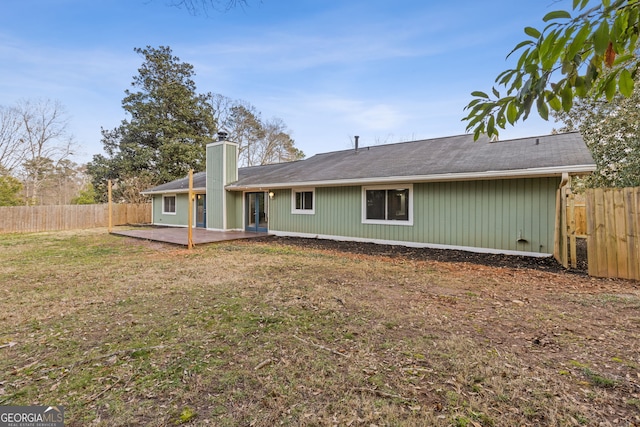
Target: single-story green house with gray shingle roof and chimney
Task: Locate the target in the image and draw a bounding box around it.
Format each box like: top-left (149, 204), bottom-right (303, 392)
top-left (144, 133), bottom-right (595, 255)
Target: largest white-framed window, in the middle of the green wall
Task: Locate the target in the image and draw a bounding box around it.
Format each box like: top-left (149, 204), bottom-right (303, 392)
top-left (362, 185), bottom-right (413, 225)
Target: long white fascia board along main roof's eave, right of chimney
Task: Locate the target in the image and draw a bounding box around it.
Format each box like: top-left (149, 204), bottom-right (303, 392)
top-left (226, 165), bottom-right (596, 191)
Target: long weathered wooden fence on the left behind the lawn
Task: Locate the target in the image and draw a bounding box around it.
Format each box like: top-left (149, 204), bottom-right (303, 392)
top-left (0, 203), bottom-right (151, 233)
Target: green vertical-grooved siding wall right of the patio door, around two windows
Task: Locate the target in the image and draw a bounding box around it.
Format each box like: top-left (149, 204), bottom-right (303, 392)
top-left (269, 178), bottom-right (559, 253)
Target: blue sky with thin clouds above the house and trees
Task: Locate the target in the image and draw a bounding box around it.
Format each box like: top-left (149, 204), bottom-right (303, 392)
top-left (0, 0), bottom-right (571, 163)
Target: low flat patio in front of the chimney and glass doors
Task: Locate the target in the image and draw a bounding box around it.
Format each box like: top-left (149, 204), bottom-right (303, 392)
top-left (111, 227), bottom-right (269, 246)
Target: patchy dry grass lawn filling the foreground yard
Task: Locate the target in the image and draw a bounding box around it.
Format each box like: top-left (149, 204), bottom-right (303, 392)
top-left (0, 231), bottom-right (640, 426)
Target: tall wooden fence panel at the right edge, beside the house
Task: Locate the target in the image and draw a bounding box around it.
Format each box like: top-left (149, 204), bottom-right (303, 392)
top-left (586, 187), bottom-right (640, 280)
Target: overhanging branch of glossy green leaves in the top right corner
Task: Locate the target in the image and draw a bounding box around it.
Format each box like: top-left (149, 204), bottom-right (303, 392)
top-left (463, 0), bottom-right (640, 140)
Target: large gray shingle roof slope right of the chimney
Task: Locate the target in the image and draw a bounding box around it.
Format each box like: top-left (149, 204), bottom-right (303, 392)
top-left (227, 132), bottom-right (594, 189)
